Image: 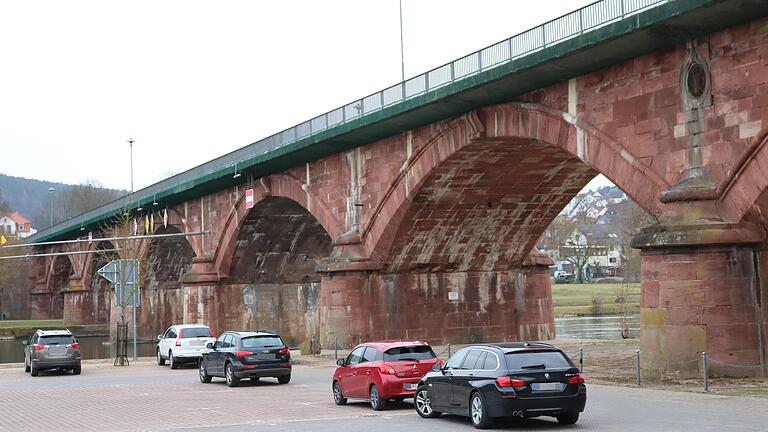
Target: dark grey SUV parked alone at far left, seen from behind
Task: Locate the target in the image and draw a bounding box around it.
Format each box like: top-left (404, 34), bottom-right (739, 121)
top-left (24, 330), bottom-right (80, 376)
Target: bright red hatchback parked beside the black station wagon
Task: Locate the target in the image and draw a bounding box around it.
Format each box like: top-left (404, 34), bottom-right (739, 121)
top-left (333, 341), bottom-right (442, 411)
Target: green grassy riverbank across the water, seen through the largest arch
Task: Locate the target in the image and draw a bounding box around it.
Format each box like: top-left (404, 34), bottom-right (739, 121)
top-left (552, 283), bottom-right (640, 316)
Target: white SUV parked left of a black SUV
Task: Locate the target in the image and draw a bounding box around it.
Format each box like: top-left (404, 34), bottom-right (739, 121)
top-left (155, 324), bottom-right (216, 369)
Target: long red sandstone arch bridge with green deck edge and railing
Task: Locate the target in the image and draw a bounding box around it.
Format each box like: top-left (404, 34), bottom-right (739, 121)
top-left (24, 0), bottom-right (768, 374)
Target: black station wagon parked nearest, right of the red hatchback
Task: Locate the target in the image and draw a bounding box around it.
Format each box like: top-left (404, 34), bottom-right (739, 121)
top-left (414, 342), bottom-right (587, 429)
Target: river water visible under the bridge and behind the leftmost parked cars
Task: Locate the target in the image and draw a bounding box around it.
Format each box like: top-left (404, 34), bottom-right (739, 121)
top-left (0, 315), bottom-right (640, 363)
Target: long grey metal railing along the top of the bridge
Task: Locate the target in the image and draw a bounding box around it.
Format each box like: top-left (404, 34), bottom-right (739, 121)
top-left (29, 0), bottom-right (669, 241)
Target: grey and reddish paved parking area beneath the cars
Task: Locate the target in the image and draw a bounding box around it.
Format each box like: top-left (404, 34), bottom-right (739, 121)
top-left (0, 361), bottom-right (768, 432)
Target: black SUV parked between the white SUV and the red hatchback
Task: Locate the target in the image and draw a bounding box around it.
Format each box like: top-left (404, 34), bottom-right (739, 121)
top-left (199, 331), bottom-right (292, 387)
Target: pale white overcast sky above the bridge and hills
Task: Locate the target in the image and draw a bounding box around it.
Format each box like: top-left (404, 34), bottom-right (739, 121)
top-left (0, 0), bottom-right (612, 189)
